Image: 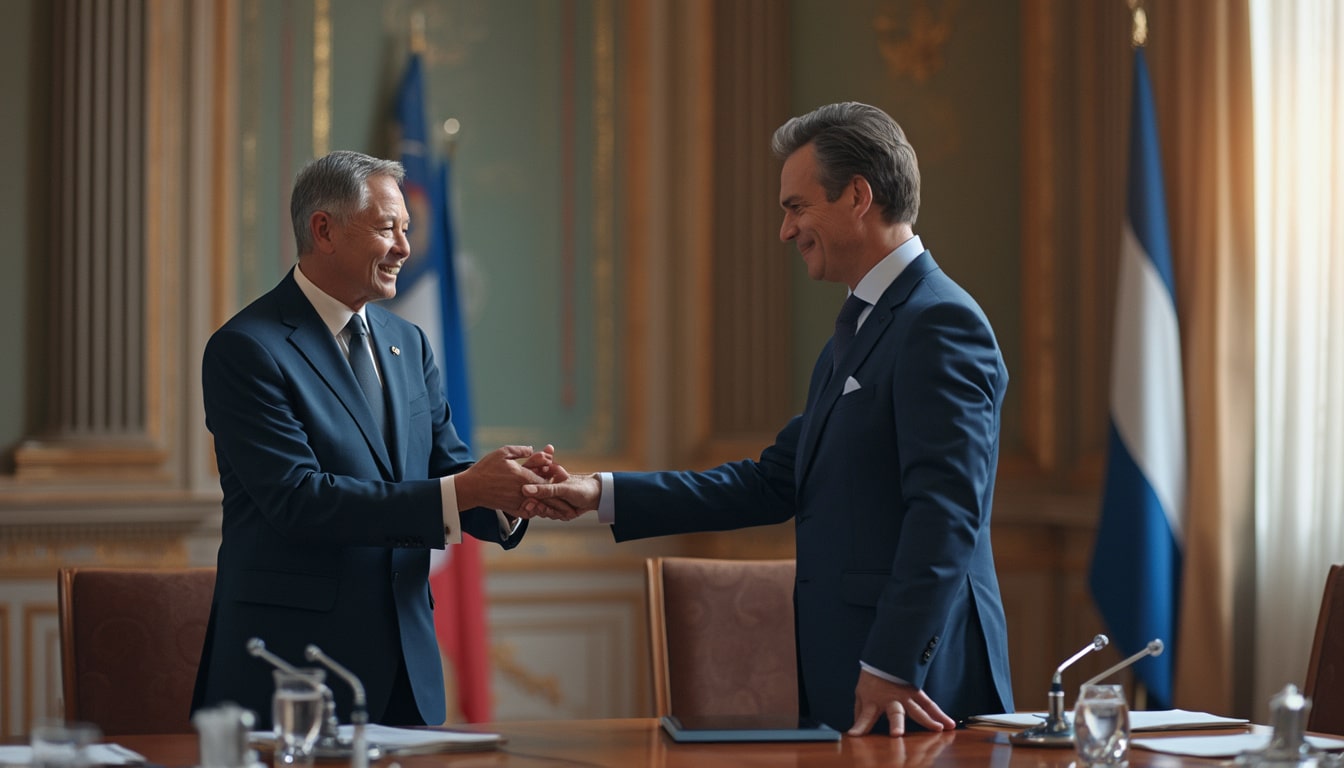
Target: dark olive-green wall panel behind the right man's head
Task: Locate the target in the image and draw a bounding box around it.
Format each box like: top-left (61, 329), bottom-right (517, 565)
top-left (790, 0), bottom-right (1021, 437)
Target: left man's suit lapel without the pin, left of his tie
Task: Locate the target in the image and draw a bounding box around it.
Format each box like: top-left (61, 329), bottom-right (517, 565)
top-left (281, 273), bottom-right (392, 479)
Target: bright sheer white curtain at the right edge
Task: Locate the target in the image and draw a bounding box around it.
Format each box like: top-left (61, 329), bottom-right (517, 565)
top-left (1250, 0), bottom-right (1344, 722)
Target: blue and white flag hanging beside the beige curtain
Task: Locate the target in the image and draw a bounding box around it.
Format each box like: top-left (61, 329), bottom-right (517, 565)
top-left (1089, 47), bottom-right (1187, 709)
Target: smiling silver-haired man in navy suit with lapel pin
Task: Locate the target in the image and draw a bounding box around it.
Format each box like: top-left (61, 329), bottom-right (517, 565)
top-left (192, 152), bottom-right (550, 728)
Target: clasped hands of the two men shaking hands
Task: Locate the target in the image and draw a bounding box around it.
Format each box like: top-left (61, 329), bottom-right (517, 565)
top-left (453, 445), bottom-right (602, 521)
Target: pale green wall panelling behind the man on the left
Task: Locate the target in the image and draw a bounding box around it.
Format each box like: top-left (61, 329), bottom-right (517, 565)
top-left (238, 0), bottom-right (622, 452)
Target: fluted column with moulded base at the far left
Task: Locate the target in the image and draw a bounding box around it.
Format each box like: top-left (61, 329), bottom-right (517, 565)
top-left (15, 0), bottom-right (230, 494)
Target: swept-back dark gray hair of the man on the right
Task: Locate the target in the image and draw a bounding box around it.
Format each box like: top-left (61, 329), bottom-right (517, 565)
top-left (770, 101), bottom-right (919, 225)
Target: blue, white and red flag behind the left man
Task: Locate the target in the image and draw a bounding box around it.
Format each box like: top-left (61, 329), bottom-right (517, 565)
top-left (390, 54), bottom-right (492, 722)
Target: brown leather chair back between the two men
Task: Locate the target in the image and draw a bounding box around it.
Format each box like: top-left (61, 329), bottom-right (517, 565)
top-left (645, 557), bottom-right (798, 717)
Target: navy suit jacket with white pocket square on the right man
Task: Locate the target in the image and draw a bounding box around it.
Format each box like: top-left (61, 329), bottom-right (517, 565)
top-left (613, 252), bottom-right (1012, 729)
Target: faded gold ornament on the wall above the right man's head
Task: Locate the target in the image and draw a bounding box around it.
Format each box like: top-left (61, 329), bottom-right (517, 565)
top-left (872, 0), bottom-right (958, 83)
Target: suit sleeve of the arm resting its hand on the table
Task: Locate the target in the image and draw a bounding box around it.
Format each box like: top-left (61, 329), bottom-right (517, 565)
top-left (862, 301), bottom-right (1005, 687)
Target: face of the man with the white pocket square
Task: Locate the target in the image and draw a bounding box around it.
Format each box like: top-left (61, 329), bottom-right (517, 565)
top-left (780, 144), bottom-right (862, 288)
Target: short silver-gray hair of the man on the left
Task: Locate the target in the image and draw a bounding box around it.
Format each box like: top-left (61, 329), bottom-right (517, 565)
top-left (289, 151), bottom-right (406, 256)
